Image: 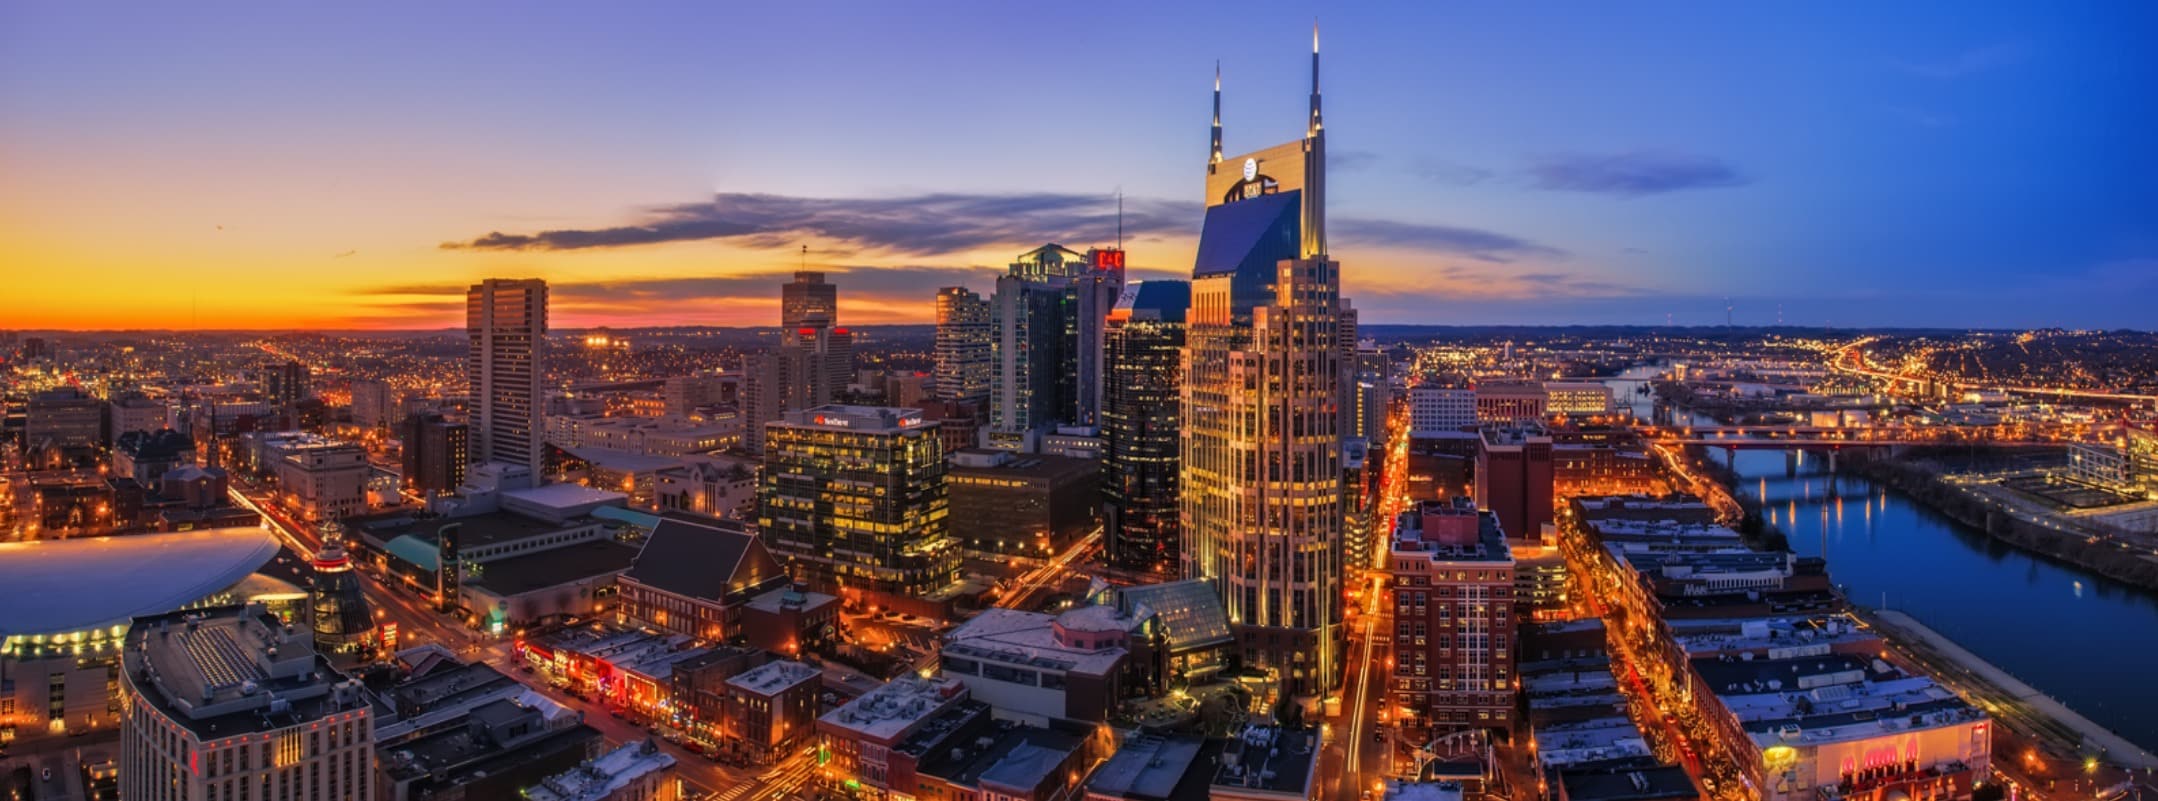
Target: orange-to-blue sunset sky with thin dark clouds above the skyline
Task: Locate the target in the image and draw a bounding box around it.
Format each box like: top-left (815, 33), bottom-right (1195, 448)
top-left (0, 2), bottom-right (2158, 328)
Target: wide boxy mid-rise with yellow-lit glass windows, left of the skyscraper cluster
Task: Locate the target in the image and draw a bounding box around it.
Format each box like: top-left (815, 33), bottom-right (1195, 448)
top-left (757, 404), bottom-right (958, 613)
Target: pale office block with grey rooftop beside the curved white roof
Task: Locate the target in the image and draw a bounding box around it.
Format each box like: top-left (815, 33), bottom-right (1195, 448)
top-left (119, 605), bottom-right (375, 801)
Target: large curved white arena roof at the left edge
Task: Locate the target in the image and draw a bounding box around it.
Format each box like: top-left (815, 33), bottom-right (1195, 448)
top-left (0, 527), bottom-right (278, 637)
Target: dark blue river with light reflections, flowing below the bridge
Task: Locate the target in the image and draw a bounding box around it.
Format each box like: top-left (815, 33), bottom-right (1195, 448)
top-left (1711, 451), bottom-right (2158, 751)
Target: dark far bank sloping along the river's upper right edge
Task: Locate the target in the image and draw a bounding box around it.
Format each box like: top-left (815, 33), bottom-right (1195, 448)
top-left (1849, 460), bottom-right (2158, 592)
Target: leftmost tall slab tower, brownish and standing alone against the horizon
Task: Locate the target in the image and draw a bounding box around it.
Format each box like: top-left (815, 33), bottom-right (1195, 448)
top-left (464, 279), bottom-right (546, 481)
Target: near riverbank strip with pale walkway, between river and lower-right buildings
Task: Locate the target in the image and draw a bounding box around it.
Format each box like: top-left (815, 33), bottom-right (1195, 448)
top-left (1860, 609), bottom-right (2158, 769)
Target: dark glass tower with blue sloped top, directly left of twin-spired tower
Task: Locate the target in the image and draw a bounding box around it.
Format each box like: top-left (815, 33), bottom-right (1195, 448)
top-left (1101, 281), bottom-right (1191, 570)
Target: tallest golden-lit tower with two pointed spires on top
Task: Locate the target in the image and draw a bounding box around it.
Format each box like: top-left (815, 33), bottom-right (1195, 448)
top-left (1180, 37), bottom-right (1347, 697)
